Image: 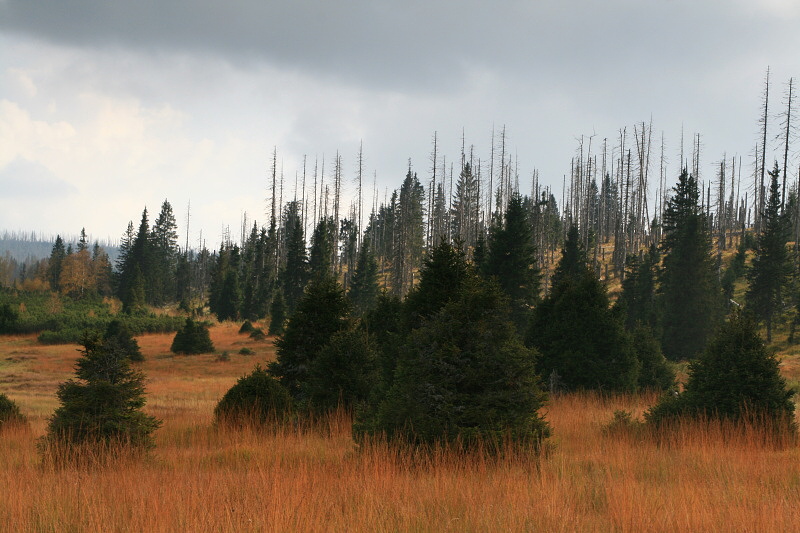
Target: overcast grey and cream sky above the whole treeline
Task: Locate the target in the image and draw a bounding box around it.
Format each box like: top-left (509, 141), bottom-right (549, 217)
top-left (0, 0), bottom-right (800, 248)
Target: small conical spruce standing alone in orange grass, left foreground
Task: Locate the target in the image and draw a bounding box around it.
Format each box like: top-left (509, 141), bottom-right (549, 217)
top-left (43, 335), bottom-right (161, 449)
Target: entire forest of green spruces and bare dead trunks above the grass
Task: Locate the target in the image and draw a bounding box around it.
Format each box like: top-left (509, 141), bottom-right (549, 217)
top-left (0, 72), bottom-right (800, 525)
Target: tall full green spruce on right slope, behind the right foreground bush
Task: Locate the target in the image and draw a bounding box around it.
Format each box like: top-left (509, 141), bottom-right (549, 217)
top-left (659, 170), bottom-right (724, 361)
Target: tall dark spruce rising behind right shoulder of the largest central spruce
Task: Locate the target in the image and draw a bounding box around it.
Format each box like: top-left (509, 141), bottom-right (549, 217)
top-left (485, 193), bottom-right (541, 335)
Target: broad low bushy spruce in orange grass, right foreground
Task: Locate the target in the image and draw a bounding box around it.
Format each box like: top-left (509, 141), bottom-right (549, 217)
top-left (646, 312), bottom-right (794, 428)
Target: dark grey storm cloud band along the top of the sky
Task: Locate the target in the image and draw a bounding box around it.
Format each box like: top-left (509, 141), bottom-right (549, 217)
top-left (0, 0), bottom-right (776, 92)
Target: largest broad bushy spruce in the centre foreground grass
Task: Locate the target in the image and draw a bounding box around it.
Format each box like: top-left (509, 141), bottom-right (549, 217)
top-left (358, 276), bottom-right (549, 449)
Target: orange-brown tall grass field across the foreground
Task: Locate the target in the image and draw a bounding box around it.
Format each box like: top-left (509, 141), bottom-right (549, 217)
top-left (0, 324), bottom-right (800, 532)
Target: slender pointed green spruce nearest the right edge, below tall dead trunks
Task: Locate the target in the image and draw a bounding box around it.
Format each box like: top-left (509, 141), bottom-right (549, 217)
top-left (745, 162), bottom-right (791, 342)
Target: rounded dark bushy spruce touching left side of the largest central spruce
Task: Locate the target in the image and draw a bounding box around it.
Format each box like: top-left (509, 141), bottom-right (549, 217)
top-left (304, 329), bottom-right (378, 412)
